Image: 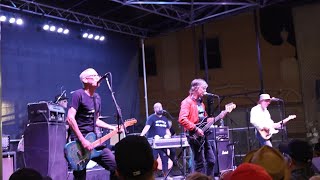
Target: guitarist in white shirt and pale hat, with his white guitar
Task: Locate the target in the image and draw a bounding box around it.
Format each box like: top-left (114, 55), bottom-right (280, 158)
top-left (250, 94), bottom-right (296, 147)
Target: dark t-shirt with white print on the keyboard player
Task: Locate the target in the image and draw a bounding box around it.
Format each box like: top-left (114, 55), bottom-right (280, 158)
top-left (146, 114), bottom-right (169, 138)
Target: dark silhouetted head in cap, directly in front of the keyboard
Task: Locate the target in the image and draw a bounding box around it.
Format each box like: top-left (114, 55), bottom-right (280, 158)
top-left (115, 135), bottom-right (158, 180)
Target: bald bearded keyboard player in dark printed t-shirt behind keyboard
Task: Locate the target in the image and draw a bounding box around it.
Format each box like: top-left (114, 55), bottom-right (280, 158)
top-left (140, 102), bottom-right (171, 176)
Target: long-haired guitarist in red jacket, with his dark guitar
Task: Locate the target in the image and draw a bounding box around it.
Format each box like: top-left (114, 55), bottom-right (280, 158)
top-left (178, 79), bottom-right (235, 177)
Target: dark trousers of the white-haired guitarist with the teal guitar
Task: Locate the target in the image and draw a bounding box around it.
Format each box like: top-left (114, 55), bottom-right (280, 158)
top-left (73, 146), bottom-right (116, 180)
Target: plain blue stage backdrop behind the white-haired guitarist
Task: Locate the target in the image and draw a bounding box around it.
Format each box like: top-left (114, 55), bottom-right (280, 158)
top-left (1, 12), bottom-right (139, 139)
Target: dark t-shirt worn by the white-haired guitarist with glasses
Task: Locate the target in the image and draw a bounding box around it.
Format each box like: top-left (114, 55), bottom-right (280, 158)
top-left (70, 89), bottom-right (101, 138)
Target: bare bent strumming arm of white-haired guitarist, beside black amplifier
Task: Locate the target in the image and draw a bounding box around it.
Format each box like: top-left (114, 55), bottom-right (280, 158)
top-left (67, 107), bottom-right (93, 150)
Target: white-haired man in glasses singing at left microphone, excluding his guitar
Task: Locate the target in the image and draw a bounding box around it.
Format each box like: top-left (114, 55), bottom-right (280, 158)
top-left (67, 68), bottom-right (117, 180)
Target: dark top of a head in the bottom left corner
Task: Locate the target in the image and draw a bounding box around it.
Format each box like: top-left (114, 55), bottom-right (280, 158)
top-left (9, 168), bottom-right (43, 180)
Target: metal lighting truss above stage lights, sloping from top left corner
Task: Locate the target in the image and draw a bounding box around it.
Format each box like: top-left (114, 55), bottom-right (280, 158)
top-left (0, 0), bottom-right (150, 38)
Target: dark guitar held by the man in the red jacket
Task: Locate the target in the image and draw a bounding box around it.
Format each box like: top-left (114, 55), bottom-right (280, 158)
top-left (189, 102), bottom-right (237, 144)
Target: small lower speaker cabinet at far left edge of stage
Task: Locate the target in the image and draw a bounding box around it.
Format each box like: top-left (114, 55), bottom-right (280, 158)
top-left (2, 151), bottom-right (16, 180)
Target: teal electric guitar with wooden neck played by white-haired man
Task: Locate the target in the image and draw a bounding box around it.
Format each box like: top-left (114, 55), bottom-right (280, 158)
top-left (64, 118), bottom-right (137, 171)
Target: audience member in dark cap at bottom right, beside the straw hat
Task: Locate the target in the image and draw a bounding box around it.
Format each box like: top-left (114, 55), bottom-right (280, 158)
top-left (279, 139), bottom-right (314, 180)
